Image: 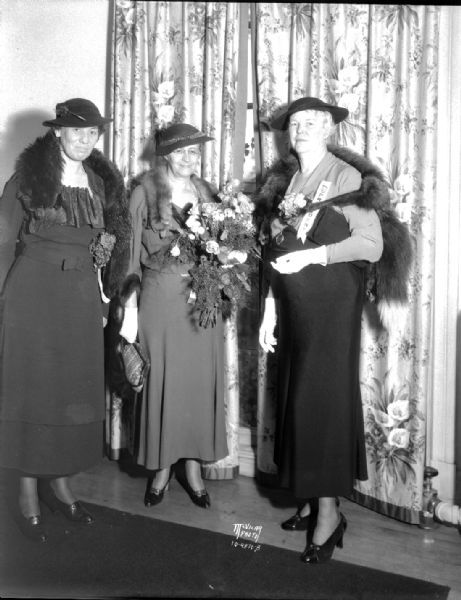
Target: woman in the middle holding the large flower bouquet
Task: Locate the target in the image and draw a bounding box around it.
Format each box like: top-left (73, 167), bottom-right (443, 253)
top-left (120, 124), bottom-right (228, 508)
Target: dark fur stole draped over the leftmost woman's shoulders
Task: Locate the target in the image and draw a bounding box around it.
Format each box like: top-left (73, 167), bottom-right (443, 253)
top-left (16, 131), bottom-right (131, 298)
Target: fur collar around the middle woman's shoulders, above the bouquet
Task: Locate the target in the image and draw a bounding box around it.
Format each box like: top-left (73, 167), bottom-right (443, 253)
top-left (130, 157), bottom-right (217, 229)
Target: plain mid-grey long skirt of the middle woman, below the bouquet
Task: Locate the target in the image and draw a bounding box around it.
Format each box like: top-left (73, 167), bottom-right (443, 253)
top-left (137, 269), bottom-right (228, 470)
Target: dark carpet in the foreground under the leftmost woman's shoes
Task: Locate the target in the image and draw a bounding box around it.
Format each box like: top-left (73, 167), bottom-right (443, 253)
top-left (0, 504), bottom-right (449, 600)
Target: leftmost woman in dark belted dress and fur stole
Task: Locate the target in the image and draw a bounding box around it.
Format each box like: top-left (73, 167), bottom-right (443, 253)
top-left (0, 98), bottom-right (130, 542)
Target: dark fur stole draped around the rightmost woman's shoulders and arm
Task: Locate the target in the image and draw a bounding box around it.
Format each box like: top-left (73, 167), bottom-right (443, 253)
top-left (254, 145), bottom-right (413, 324)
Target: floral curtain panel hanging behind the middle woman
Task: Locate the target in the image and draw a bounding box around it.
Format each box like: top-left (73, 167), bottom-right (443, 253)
top-left (107, 0), bottom-right (246, 478)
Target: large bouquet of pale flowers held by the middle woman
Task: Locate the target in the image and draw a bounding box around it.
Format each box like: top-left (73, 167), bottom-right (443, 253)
top-left (168, 182), bottom-right (258, 327)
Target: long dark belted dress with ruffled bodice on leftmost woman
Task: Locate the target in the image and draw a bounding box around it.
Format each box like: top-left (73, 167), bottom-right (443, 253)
top-left (0, 169), bottom-right (105, 476)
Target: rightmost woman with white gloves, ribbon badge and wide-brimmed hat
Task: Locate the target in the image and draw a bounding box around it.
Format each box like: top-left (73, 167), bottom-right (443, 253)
top-left (258, 97), bottom-right (384, 563)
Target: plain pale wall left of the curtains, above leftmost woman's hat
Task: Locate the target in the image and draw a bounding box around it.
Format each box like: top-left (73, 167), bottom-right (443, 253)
top-left (0, 0), bottom-right (112, 190)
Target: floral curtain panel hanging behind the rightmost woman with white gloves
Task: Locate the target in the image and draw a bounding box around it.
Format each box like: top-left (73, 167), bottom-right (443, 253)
top-left (252, 3), bottom-right (440, 523)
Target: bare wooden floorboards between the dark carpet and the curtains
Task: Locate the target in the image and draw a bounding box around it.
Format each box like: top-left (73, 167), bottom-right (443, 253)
top-left (68, 459), bottom-right (461, 600)
